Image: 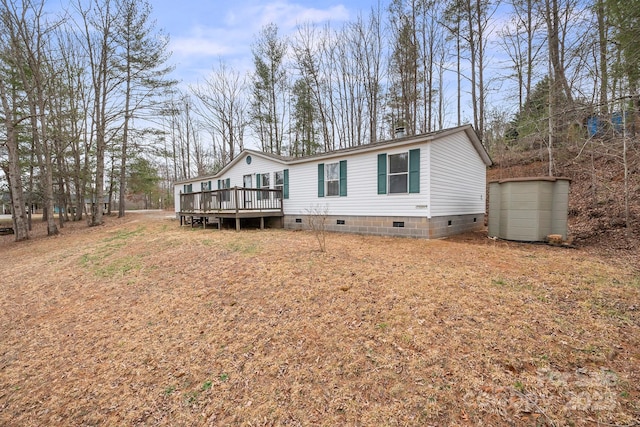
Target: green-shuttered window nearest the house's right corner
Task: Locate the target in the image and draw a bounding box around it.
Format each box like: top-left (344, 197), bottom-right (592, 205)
top-left (378, 148), bottom-right (420, 194)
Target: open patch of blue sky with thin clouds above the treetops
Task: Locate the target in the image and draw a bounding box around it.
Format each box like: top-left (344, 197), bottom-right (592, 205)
top-left (152, 0), bottom-right (372, 85)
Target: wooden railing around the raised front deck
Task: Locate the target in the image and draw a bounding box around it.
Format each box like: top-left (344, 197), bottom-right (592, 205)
top-left (180, 187), bottom-right (282, 213)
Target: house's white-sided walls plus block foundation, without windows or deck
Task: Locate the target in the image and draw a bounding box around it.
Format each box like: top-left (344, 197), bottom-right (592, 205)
top-left (175, 127), bottom-right (486, 238)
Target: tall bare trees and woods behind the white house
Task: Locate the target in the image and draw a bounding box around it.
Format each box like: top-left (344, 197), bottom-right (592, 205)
top-left (0, 0), bottom-right (640, 240)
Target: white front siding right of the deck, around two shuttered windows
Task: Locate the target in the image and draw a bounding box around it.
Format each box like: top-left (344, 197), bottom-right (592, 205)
top-left (284, 143), bottom-right (429, 217)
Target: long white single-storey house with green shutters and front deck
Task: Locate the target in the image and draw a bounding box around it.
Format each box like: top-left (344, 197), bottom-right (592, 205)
top-left (175, 125), bottom-right (491, 238)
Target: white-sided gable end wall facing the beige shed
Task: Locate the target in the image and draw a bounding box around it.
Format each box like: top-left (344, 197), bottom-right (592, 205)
top-left (431, 132), bottom-right (487, 217)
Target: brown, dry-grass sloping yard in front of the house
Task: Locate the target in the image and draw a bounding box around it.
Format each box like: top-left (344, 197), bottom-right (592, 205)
top-left (0, 214), bottom-right (640, 426)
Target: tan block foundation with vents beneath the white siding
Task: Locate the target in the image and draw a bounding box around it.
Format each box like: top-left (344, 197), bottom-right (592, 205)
top-left (284, 214), bottom-right (484, 239)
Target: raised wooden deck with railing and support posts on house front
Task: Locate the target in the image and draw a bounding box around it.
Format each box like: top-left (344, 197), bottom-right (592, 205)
top-left (178, 187), bottom-right (284, 230)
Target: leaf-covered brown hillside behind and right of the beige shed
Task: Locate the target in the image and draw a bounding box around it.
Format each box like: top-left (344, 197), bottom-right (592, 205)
top-left (488, 140), bottom-right (640, 263)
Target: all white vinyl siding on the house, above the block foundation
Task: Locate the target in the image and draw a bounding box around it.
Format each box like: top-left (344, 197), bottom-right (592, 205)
top-left (175, 131), bottom-right (486, 218)
